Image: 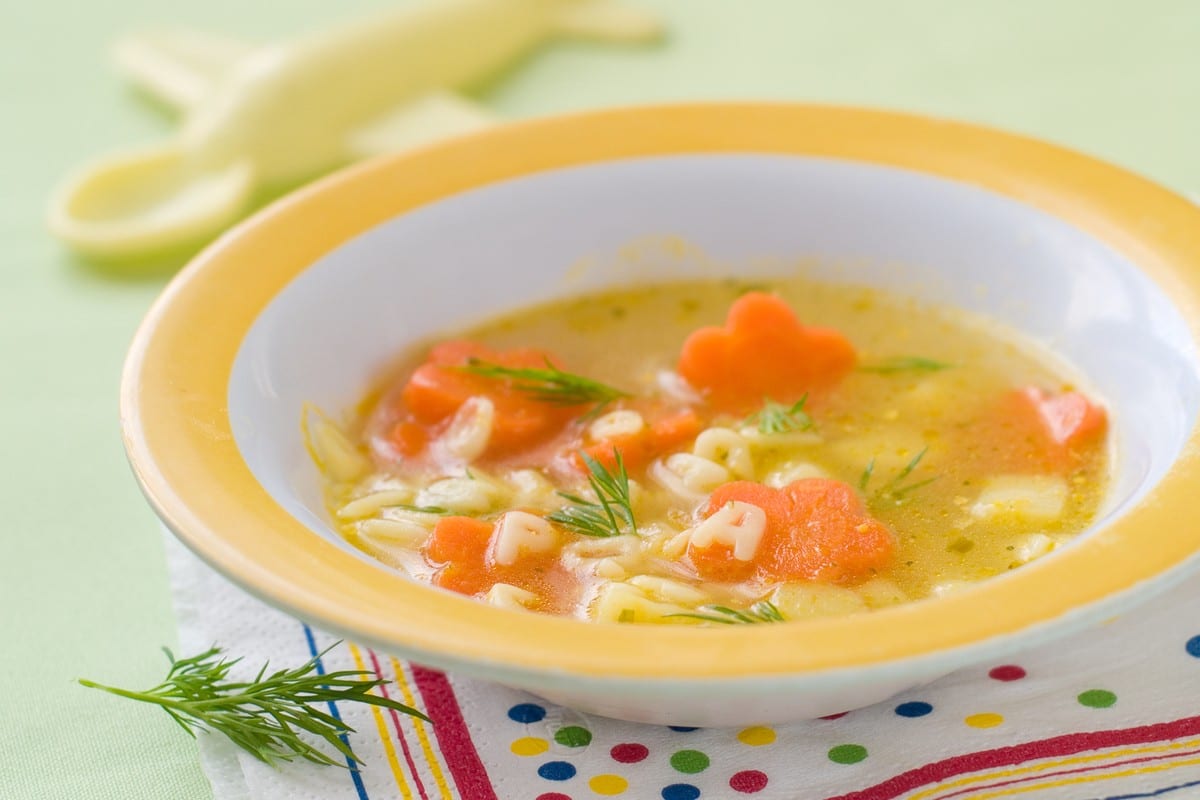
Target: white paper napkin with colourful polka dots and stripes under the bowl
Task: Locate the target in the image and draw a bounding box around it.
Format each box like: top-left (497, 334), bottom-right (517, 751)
top-left (168, 540), bottom-right (1200, 800)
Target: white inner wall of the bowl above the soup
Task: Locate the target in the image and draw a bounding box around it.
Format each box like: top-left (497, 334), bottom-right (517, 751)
top-left (229, 155), bottom-right (1200, 566)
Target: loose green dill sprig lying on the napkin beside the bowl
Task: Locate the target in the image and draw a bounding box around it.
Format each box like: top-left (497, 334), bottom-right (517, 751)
top-left (79, 644), bottom-right (430, 765)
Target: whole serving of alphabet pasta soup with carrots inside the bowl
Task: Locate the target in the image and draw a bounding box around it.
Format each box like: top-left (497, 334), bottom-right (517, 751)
top-left (308, 282), bottom-right (1109, 625)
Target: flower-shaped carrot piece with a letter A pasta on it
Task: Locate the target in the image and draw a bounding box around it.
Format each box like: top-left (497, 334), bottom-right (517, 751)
top-left (688, 477), bottom-right (895, 583)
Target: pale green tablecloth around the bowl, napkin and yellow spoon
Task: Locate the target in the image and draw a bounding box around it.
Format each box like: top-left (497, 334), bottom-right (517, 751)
top-left (0, 0), bottom-right (1200, 800)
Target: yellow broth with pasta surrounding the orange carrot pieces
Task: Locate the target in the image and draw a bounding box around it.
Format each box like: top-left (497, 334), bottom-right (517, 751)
top-left (313, 279), bottom-right (1111, 624)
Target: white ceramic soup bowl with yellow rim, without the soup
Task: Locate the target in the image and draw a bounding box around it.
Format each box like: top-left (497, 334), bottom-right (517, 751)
top-left (121, 104), bottom-right (1200, 726)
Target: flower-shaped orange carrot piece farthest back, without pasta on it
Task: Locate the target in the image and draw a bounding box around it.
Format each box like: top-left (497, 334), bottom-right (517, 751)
top-left (678, 291), bottom-right (854, 414)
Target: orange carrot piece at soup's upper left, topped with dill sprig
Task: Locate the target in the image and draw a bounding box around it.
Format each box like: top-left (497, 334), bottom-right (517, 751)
top-left (401, 341), bottom-right (578, 458)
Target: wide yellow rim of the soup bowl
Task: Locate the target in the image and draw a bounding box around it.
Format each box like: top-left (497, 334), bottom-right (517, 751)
top-left (121, 103), bottom-right (1200, 680)
